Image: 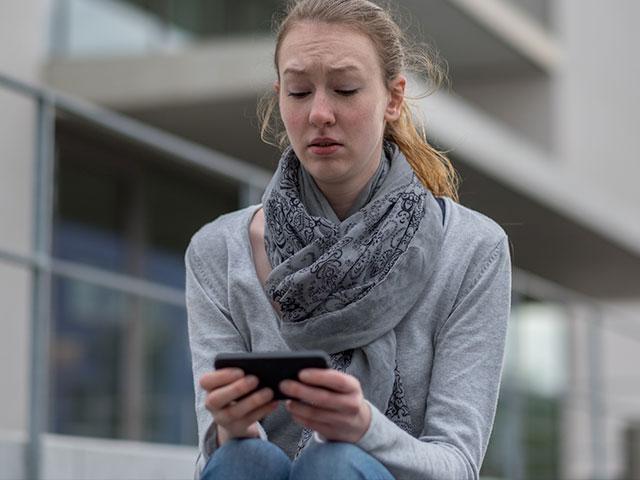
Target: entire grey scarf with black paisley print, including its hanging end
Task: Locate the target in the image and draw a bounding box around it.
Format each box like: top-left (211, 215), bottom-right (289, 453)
top-left (263, 142), bottom-right (443, 447)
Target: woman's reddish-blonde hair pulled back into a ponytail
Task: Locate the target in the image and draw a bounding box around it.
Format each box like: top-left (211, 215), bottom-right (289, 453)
top-left (258, 0), bottom-right (458, 201)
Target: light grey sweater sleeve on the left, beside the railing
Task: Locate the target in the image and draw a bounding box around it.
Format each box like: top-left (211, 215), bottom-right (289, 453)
top-left (185, 241), bottom-right (267, 478)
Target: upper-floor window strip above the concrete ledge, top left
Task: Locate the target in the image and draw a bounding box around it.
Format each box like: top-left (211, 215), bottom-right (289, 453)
top-left (51, 0), bottom-right (284, 57)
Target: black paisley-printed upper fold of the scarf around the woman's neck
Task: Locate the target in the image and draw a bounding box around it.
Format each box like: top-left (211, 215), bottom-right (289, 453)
top-left (264, 144), bottom-right (425, 322)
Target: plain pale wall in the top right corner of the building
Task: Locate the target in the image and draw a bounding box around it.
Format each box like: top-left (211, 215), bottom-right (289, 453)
top-left (558, 0), bottom-right (640, 210)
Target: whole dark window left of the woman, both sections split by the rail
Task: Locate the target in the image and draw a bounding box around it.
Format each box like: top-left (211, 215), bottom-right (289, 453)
top-left (50, 121), bottom-right (239, 444)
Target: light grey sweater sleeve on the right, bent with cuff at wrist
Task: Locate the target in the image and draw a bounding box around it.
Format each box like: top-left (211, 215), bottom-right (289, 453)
top-left (350, 237), bottom-right (511, 480)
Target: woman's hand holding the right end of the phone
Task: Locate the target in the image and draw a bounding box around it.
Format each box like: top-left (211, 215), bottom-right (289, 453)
top-left (280, 368), bottom-right (371, 443)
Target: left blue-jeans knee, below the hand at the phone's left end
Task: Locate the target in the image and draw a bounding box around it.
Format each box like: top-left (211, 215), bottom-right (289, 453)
top-left (201, 438), bottom-right (291, 480)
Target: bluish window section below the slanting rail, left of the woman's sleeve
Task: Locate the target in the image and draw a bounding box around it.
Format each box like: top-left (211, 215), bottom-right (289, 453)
top-left (50, 278), bottom-right (197, 444)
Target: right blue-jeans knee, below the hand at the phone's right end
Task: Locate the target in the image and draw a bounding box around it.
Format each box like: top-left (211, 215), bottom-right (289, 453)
top-left (290, 442), bottom-right (393, 480)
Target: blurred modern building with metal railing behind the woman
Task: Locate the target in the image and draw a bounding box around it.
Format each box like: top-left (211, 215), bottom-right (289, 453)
top-left (0, 0), bottom-right (640, 480)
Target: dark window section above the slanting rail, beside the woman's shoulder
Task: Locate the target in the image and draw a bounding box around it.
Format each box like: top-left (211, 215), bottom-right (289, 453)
top-left (53, 122), bottom-right (239, 288)
